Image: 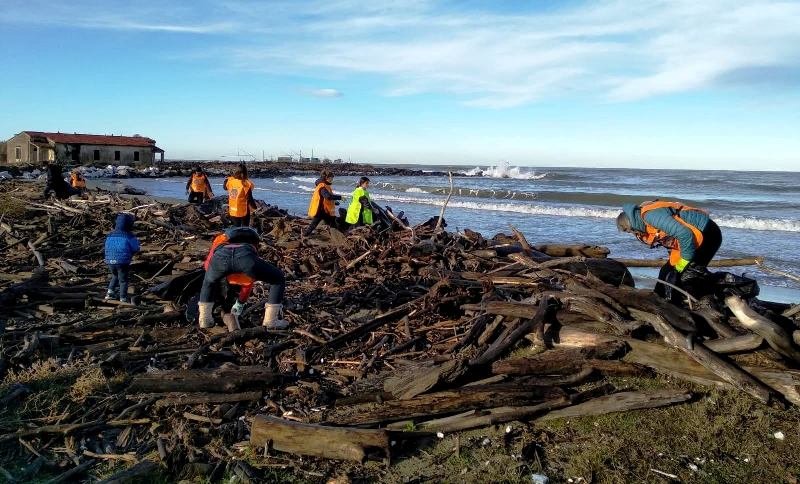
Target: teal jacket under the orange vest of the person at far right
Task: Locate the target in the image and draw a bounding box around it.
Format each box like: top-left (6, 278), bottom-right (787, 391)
top-left (622, 203), bottom-right (709, 262)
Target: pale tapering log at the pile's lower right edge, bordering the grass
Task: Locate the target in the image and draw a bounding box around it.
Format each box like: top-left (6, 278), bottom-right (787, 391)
top-left (538, 390), bottom-right (692, 420)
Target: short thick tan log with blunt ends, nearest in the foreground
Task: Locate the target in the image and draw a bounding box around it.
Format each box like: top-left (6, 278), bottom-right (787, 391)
top-left (250, 415), bottom-right (391, 463)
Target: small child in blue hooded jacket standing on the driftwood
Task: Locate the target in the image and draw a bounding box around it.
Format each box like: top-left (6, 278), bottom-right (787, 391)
top-left (105, 213), bottom-right (140, 302)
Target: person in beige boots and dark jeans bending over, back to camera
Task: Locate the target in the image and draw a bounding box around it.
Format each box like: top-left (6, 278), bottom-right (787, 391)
top-left (198, 227), bottom-right (289, 331)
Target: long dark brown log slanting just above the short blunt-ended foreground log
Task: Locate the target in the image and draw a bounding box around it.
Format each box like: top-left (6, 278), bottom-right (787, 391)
top-left (328, 383), bottom-right (565, 425)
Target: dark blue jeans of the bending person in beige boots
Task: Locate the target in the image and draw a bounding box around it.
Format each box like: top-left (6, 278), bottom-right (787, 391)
top-left (200, 244), bottom-right (286, 304)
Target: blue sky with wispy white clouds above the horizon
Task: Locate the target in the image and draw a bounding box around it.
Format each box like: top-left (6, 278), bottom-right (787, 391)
top-left (0, 0), bottom-right (800, 171)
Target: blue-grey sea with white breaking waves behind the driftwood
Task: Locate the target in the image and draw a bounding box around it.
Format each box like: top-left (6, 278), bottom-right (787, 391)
top-left (119, 165), bottom-right (800, 303)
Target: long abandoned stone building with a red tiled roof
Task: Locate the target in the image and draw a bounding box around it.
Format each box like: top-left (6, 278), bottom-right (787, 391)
top-left (5, 131), bottom-right (164, 165)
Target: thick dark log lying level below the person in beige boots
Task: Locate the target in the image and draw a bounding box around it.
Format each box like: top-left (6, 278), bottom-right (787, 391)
top-left (128, 366), bottom-right (279, 392)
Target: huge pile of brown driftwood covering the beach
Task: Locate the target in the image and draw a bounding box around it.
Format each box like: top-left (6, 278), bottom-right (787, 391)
top-left (0, 180), bottom-right (800, 482)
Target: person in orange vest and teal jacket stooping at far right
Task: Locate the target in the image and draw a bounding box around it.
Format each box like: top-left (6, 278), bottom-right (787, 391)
top-left (617, 200), bottom-right (722, 301)
